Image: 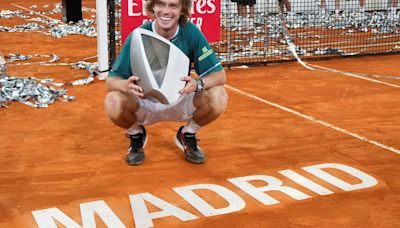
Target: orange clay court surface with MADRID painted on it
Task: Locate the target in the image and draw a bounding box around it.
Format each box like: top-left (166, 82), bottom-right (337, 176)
top-left (0, 0), bottom-right (400, 227)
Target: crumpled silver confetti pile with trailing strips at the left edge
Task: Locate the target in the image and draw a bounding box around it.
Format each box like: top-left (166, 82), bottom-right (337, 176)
top-left (0, 53), bottom-right (97, 108)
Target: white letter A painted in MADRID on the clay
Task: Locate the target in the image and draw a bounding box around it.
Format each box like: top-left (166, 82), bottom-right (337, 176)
top-left (129, 192), bottom-right (197, 228)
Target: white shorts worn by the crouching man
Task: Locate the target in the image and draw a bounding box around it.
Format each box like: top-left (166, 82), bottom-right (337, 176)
top-left (136, 93), bottom-right (196, 125)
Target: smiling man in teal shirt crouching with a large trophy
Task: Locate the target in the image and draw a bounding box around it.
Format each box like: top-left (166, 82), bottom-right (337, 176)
top-left (105, 0), bottom-right (228, 165)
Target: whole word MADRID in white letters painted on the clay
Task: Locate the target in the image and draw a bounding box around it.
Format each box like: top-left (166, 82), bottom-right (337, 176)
top-left (32, 163), bottom-right (378, 228)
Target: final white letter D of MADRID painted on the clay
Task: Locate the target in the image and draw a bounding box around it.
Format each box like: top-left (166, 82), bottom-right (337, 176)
top-left (303, 163), bottom-right (378, 191)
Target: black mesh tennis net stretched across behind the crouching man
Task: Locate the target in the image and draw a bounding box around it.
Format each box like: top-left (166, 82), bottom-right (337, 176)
top-left (108, 0), bottom-right (400, 67)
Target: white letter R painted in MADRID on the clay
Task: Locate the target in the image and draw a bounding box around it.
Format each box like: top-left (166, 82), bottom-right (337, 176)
top-left (228, 175), bottom-right (310, 205)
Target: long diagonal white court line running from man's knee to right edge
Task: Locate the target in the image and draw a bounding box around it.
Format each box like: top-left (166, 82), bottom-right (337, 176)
top-left (225, 84), bottom-right (400, 154)
